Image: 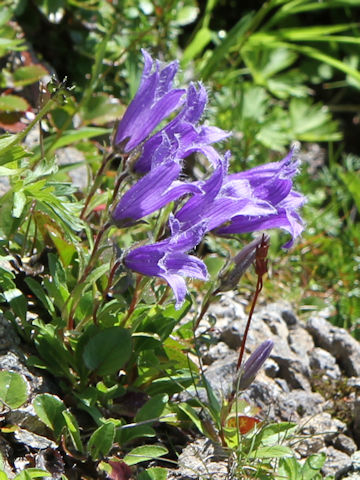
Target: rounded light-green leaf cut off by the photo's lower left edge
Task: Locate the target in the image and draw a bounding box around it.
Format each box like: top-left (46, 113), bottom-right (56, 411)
top-left (0, 370), bottom-right (29, 408)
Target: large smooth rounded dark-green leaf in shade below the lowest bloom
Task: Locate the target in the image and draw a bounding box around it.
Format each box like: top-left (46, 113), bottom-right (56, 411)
top-left (83, 327), bottom-right (132, 375)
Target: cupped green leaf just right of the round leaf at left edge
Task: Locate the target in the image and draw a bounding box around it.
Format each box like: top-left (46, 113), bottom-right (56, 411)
top-left (33, 393), bottom-right (66, 438)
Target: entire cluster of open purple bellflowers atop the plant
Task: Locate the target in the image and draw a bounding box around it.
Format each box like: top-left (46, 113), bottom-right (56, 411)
top-left (112, 51), bottom-right (305, 307)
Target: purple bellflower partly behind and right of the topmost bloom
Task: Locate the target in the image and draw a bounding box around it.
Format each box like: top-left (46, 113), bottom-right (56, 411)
top-left (134, 83), bottom-right (230, 173)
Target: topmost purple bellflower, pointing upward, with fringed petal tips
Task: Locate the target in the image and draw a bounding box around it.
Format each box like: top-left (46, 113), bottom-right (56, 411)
top-left (114, 50), bottom-right (185, 153)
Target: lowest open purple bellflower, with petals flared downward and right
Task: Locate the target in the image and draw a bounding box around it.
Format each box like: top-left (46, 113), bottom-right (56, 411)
top-left (124, 225), bottom-right (208, 308)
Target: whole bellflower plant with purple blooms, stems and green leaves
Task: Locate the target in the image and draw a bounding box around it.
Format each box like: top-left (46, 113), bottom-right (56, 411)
top-left (0, 46), bottom-right (305, 478)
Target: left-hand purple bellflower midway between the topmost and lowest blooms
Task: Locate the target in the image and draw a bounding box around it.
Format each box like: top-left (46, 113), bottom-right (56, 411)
top-left (112, 135), bottom-right (200, 227)
